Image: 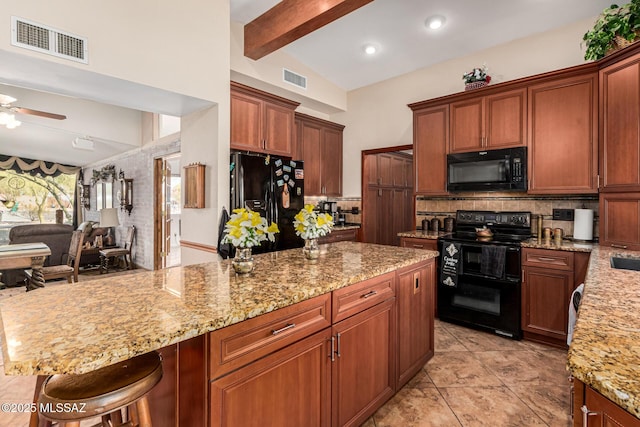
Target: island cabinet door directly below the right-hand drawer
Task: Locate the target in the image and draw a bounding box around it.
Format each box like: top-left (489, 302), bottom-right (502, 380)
top-left (330, 298), bottom-right (396, 426)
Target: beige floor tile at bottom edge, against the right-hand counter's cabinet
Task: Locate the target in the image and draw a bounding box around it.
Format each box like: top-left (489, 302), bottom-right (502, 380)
top-left (509, 383), bottom-right (571, 427)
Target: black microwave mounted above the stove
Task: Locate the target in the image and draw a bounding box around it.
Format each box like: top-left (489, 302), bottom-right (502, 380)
top-left (447, 147), bottom-right (527, 192)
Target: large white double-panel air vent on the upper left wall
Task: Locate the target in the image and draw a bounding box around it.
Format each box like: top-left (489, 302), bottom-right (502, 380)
top-left (11, 16), bottom-right (89, 64)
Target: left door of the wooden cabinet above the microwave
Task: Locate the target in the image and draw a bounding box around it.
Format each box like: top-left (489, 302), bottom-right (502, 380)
top-left (449, 97), bottom-right (485, 153)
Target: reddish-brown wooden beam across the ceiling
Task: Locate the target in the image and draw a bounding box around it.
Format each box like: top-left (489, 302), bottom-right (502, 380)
top-left (244, 0), bottom-right (373, 60)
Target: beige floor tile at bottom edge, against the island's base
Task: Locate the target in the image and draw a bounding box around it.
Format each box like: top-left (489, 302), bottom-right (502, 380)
top-left (373, 388), bottom-right (461, 427)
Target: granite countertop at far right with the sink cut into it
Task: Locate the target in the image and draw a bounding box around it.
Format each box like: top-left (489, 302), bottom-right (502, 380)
top-left (568, 245), bottom-right (640, 418)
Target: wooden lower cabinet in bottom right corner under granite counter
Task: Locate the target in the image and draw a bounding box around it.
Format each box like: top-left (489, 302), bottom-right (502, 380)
top-left (572, 378), bottom-right (640, 427)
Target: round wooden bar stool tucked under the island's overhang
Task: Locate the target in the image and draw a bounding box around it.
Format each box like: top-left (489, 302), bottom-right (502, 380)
top-left (38, 351), bottom-right (162, 427)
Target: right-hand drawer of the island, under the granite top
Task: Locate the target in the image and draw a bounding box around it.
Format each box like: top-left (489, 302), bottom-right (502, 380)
top-left (331, 272), bottom-right (396, 323)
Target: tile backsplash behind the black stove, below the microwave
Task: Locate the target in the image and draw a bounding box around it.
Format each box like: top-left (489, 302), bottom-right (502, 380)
top-left (416, 193), bottom-right (599, 238)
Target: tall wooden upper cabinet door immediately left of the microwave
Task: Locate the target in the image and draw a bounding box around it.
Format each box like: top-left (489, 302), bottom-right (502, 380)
top-left (413, 105), bottom-right (449, 195)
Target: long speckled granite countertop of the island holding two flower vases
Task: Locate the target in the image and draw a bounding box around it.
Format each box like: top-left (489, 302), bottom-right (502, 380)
top-left (0, 242), bottom-right (437, 375)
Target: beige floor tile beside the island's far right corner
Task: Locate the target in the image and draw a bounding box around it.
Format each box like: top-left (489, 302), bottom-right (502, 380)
top-left (425, 351), bottom-right (502, 388)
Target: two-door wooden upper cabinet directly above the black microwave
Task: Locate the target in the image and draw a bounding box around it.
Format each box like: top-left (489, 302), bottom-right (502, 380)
top-left (449, 89), bottom-right (527, 153)
